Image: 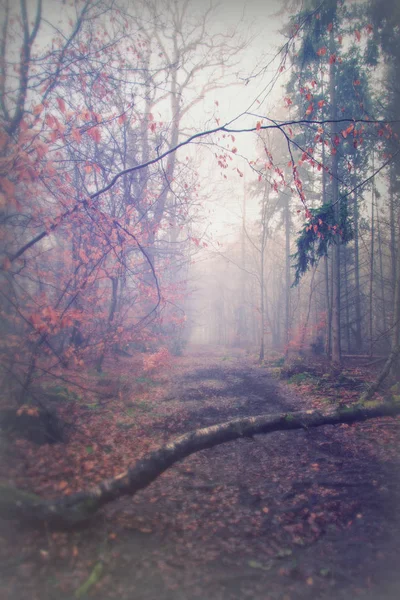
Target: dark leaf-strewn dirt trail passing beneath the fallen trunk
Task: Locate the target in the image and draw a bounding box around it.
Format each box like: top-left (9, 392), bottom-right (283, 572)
top-left (3, 350), bottom-right (400, 600)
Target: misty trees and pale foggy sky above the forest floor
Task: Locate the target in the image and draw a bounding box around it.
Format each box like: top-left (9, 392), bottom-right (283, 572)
top-left (1, 0), bottom-right (397, 380)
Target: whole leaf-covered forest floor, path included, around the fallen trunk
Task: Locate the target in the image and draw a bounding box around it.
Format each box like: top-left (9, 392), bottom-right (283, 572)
top-left (0, 348), bottom-right (400, 600)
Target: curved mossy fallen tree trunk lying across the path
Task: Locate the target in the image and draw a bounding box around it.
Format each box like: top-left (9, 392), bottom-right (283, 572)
top-left (0, 402), bottom-right (400, 526)
